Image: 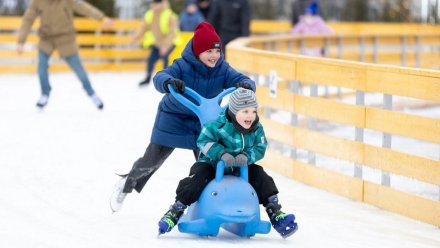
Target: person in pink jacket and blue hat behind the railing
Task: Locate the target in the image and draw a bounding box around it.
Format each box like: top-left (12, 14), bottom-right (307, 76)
top-left (290, 2), bottom-right (334, 56)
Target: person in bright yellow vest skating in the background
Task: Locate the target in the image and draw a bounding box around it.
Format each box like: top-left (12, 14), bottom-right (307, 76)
top-left (132, 0), bottom-right (181, 86)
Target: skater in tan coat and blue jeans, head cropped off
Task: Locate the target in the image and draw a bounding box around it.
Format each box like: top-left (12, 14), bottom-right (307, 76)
top-left (17, 0), bottom-right (113, 109)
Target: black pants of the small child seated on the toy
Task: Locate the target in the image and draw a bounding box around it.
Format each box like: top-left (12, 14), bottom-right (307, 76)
top-left (176, 162), bottom-right (278, 206)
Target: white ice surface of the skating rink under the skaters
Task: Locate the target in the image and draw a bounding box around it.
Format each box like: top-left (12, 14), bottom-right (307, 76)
top-left (0, 72), bottom-right (440, 248)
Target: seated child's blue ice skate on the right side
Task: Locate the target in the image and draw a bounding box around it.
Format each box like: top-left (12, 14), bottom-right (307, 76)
top-left (265, 195), bottom-right (298, 238)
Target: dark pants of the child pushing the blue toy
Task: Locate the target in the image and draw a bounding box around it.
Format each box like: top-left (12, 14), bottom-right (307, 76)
top-left (123, 144), bottom-right (198, 193)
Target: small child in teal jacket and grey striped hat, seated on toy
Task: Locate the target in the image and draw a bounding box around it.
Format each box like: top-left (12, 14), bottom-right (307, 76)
top-left (159, 88), bottom-right (298, 238)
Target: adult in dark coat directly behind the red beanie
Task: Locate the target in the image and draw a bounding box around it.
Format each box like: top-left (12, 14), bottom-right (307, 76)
top-left (208, 0), bottom-right (251, 46)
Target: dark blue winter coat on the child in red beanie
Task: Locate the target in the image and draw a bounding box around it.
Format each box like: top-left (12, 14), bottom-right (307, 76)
top-left (151, 39), bottom-right (255, 150)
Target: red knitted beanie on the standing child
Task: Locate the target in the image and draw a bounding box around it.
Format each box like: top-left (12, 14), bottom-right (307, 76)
top-left (193, 22), bottom-right (222, 56)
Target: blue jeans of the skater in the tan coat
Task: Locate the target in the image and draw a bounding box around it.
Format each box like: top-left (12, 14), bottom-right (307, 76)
top-left (38, 50), bottom-right (95, 96)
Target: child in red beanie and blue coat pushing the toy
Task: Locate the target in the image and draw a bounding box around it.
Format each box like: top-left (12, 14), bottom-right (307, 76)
top-left (110, 22), bottom-right (255, 212)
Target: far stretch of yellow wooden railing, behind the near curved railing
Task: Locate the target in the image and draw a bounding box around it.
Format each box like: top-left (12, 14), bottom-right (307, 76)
top-left (250, 31), bottom-right (440, 70)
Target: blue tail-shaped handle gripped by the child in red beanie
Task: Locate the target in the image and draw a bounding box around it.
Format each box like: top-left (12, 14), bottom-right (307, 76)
top-left (168, 87), bottom-right (235, 126)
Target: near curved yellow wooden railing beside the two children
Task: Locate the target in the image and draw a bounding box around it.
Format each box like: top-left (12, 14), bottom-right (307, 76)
top-left (226, 37), bottom-right (440, 226)
